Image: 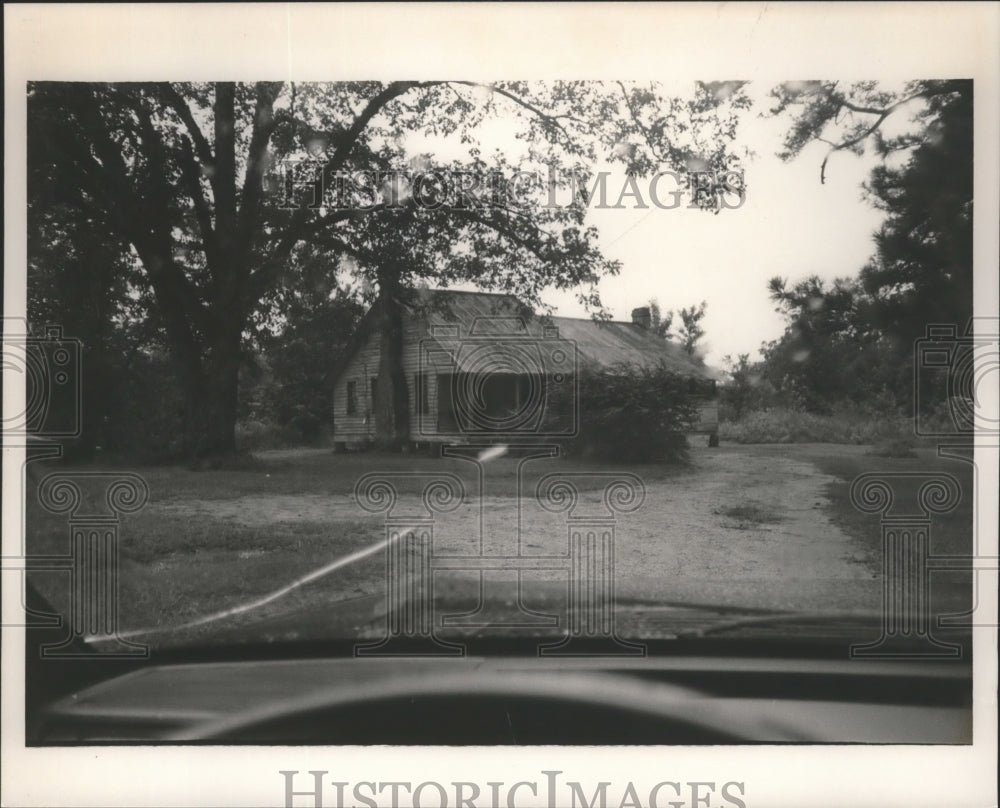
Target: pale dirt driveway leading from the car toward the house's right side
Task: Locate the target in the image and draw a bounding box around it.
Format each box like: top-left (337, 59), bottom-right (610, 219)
top-left (149, 446), bottom-right (881, 610)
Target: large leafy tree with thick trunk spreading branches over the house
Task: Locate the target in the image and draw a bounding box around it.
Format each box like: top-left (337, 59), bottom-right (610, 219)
top-left (28, 81), bottom-right (745, 459)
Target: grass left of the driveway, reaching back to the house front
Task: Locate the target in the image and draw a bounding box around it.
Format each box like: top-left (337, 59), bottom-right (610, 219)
top-left (26, 449), bottom-right (683, 642)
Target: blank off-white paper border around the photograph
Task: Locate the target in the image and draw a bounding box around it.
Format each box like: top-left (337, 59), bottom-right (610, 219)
top-left (2, 3), bottom-right (1000, 808)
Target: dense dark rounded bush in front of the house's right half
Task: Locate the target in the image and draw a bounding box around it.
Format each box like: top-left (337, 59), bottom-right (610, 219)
top-left (553, 365), bottom-right (698, 463)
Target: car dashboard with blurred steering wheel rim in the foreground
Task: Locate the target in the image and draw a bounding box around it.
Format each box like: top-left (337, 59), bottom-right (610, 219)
top-left (28, 638), bottom-right (972, 746)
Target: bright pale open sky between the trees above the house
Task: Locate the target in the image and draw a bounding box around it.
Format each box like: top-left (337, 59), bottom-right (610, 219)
top-left (414, 84), bottom-right (908, 367)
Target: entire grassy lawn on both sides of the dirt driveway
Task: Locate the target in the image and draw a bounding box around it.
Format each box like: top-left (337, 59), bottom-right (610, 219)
top-left (26, 444), bottom-right (973, 643)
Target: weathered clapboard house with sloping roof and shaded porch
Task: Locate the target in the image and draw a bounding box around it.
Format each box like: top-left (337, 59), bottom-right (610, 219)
top-left (333, 289), bottom-right (718, 449)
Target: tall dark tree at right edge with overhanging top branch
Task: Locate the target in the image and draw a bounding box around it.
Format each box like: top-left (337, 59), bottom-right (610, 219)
top-left (765, 80), bottom-right (973, 410)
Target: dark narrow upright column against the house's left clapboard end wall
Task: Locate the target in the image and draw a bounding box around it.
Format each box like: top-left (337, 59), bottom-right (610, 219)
top-left (375, 273), bottom-right (410, 451)
